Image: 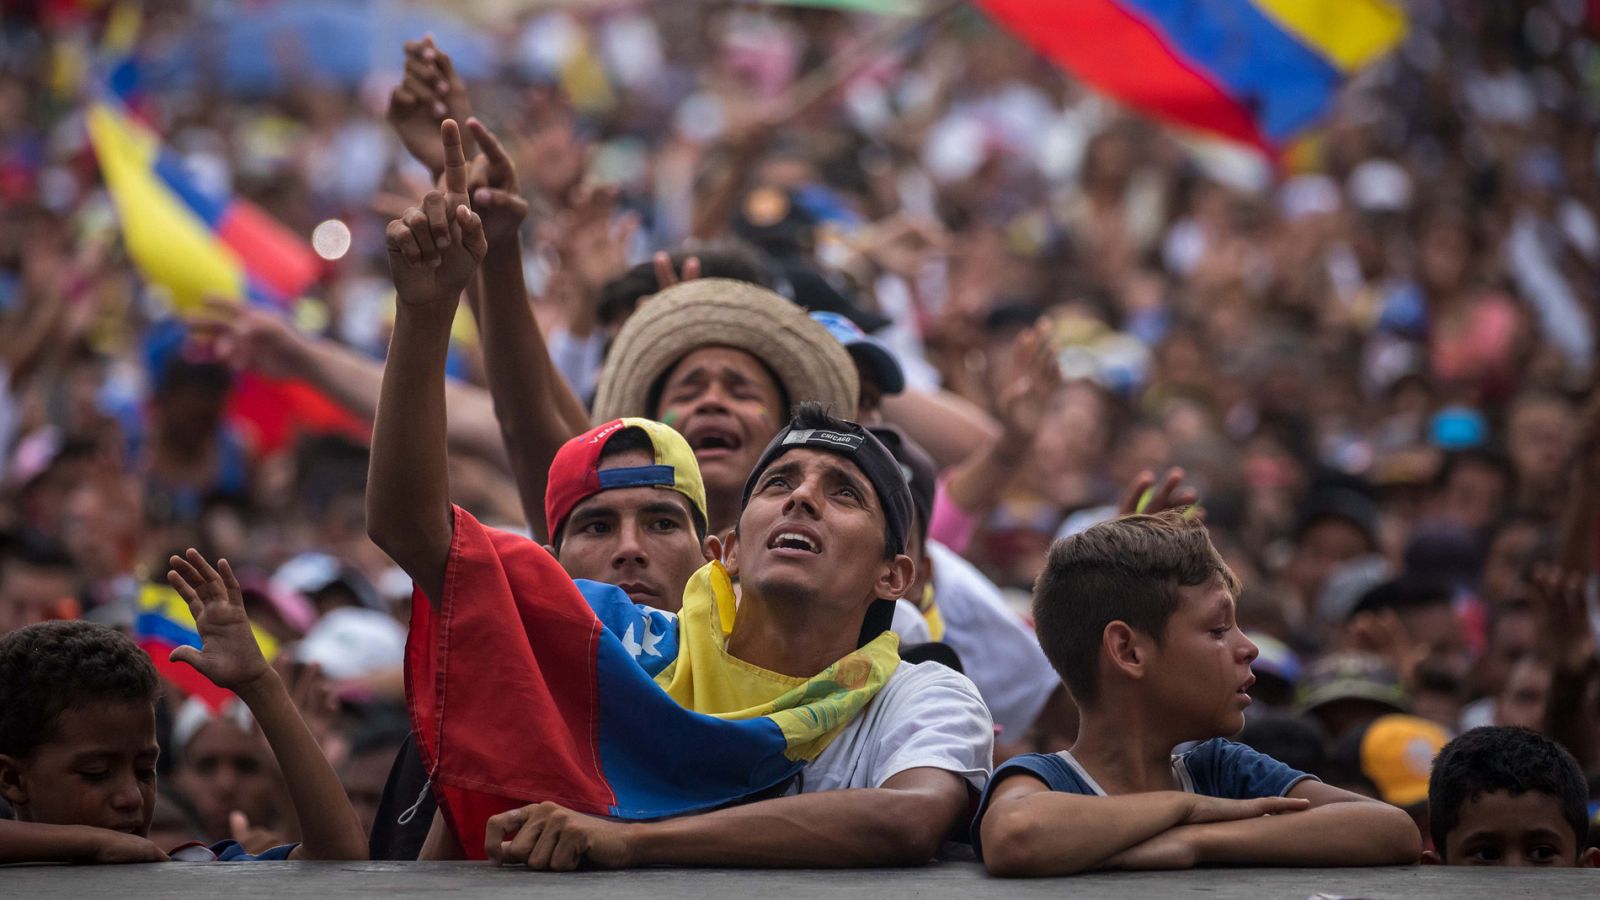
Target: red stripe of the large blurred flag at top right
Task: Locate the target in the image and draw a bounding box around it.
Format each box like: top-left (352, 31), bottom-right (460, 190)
top-left (978, 0), bottom-right (1266, 147)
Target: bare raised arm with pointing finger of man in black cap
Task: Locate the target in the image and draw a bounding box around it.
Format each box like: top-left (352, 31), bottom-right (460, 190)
top-left (366, 119), bottom-right (486, 604)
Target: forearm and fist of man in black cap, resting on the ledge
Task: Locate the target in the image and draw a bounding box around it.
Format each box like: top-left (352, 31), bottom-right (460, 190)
top-left (485, 769), bottom-right (966, 871)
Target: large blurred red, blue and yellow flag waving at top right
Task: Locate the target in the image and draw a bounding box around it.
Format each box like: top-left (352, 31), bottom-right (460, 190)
top-left (978, 0), bottom-right (1406, 151)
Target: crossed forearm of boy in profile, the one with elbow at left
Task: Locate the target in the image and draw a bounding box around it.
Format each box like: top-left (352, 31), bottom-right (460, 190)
top-left (979, 775), bottom-right (1305, 876)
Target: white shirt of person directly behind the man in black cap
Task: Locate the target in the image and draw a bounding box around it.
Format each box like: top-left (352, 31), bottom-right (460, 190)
top-left (928, 541), bottom-right (1061, 740)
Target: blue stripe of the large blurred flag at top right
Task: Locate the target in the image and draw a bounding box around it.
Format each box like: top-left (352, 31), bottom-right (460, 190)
top-left (1117, 0), bottom-right (1342, 143)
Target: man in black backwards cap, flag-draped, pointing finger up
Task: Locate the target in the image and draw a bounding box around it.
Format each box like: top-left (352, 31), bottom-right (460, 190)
top-left (368, 122), bottom-right (992, 870)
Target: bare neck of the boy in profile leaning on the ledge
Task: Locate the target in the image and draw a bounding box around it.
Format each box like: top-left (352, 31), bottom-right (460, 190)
top-left (1072, 697), bottom-right (1181, 794)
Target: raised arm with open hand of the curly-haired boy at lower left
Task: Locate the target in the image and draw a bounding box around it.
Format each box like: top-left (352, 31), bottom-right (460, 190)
top-left (166, 548), bottom-right (366, 860)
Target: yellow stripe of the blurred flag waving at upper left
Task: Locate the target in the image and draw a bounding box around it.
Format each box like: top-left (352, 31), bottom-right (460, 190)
top-left (88, 104), bottom-right (245, 312)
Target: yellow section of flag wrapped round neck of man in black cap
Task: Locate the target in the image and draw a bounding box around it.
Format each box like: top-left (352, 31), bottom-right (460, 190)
top-left (656, 562), bottom-right (899, 761)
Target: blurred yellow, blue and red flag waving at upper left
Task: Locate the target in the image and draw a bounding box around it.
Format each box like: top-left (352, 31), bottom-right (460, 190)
top-left (88, 102), bottom-right (322, 312)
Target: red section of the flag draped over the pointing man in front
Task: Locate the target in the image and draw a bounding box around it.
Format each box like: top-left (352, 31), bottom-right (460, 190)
top-left (406, 508), bottom-right (616, 860)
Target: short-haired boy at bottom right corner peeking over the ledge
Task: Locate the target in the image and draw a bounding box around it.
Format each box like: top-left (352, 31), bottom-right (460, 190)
top-left (1424, 725), bottom-right (1600, 868)
